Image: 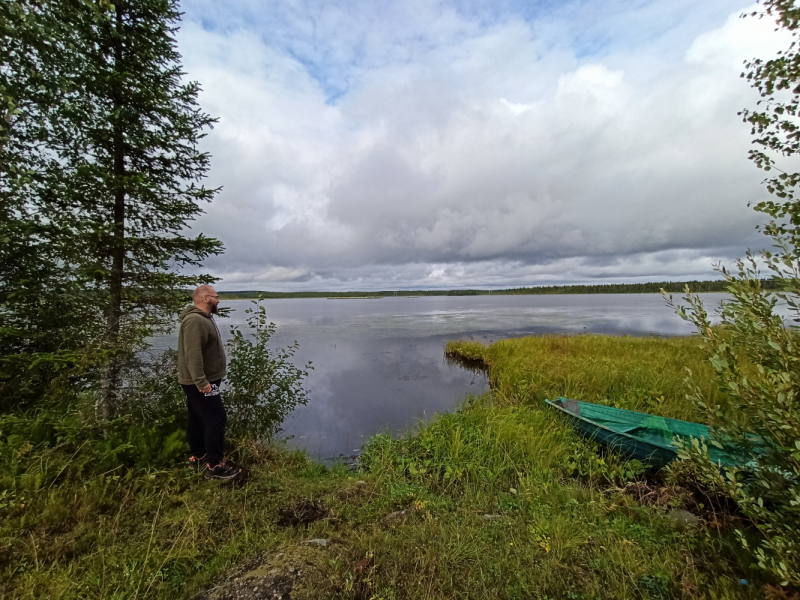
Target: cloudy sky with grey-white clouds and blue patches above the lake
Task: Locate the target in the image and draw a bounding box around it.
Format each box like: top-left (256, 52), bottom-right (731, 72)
top-left (173, 0), bottom-right (786, 291)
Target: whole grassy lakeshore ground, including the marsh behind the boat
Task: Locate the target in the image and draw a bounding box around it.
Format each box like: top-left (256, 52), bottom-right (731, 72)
top-left (0, 336), bottom-right (764, 600)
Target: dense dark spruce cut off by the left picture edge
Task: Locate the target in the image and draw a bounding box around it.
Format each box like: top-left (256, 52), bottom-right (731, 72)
top-left (0, 0), bottom-right (97, 407)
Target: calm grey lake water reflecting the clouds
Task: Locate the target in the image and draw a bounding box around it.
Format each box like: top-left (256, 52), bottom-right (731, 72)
top-left (153, 294), bottom-right (725, 460)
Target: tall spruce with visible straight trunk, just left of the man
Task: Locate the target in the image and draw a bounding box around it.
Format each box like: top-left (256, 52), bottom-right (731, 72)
top-left (65, 0), bottom-right (221, 418)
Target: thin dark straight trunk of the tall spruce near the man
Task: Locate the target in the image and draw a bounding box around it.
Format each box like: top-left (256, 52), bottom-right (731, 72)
top-left (100, 2), bottom-right (125, 420)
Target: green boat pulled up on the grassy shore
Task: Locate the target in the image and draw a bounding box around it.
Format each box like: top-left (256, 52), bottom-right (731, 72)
top-left (545, 398), bottom-right (753, 469)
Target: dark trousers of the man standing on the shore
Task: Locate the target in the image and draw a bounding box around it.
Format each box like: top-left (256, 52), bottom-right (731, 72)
top-left (183, 379), bottom-right (228, 467)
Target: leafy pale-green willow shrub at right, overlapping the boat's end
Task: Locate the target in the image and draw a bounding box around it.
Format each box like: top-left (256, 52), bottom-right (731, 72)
top-left (678, 253), bottom-right (800, 586)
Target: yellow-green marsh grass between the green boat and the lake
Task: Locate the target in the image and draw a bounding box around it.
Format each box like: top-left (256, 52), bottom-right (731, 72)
top-left (446, 335), bottom-right (718, 421)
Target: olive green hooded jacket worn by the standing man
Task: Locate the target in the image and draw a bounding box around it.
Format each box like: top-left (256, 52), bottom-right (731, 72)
top-left (178, 304), bottom-right (227, 389)
